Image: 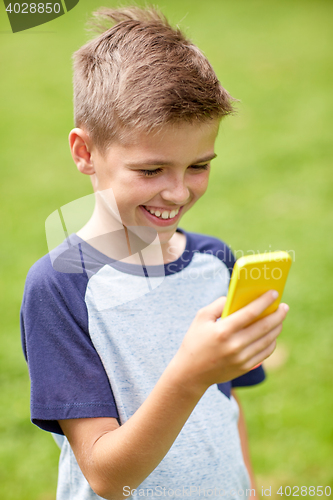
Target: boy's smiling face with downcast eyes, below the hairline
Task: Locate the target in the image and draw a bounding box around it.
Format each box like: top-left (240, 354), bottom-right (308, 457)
top-left (85, 120), bottom-right (220, 245)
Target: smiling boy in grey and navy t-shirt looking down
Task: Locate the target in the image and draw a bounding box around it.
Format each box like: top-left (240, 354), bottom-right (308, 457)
top-left (22, 4), bottom-right (288, 500)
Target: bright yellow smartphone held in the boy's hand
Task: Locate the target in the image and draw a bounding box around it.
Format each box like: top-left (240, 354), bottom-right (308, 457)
top-left (222, 251), bottom-right (291, 321)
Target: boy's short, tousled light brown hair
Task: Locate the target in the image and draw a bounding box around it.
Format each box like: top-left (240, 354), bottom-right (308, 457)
top-left (73, 7), bottom-right (235, 152)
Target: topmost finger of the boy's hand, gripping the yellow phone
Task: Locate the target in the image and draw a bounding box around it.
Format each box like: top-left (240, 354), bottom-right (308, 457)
top-left (223, 290), bottom-right (278, 332)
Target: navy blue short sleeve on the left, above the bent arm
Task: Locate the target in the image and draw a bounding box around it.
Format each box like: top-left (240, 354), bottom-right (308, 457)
top-left (21, 255), bottom-right (118, 434)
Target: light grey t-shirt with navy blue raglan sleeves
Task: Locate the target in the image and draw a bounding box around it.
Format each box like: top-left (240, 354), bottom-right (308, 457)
top-left (21, 229), bottom-right (265, 500)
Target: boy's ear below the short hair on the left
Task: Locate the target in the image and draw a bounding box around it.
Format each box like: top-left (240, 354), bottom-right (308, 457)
top-left (68, 128), bottom-right (95, 175)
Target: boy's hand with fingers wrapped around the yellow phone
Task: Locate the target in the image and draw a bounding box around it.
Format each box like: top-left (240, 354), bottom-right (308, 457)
top-left (173, 290), bottom-right (289, 391)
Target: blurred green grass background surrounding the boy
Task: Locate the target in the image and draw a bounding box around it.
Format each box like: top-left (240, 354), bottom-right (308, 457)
top-left (0, 0), bottom-right (333, 500)
